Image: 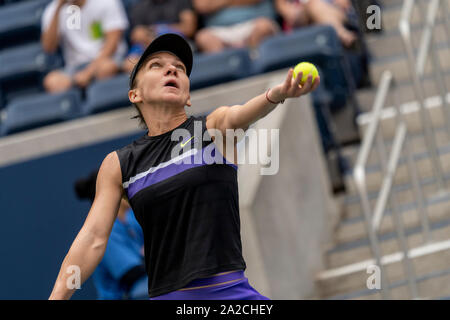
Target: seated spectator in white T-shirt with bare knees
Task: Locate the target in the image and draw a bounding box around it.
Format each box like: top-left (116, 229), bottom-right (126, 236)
top-left (41, 0), bottom-right (128, 92)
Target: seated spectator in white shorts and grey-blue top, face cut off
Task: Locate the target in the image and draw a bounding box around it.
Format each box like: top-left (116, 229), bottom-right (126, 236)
top-left (193, 0), bottom-right (279, 52)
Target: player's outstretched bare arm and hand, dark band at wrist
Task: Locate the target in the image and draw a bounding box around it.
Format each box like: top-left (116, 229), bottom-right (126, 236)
top-left (208, 69), bottom-right (320, 133)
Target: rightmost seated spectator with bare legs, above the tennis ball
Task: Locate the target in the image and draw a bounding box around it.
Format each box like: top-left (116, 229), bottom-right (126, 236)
top-left (275, 0), bottom-right (357, 47)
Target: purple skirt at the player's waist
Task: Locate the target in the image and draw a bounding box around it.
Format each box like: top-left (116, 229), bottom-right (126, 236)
top-left (150, 271), bottom-right (270, 300)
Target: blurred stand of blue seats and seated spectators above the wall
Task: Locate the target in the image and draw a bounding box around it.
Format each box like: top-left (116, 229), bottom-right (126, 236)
top-left (0, 0), bottom-right (377, 151)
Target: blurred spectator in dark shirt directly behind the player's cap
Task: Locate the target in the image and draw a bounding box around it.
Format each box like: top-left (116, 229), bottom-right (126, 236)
top-left (123, 0), bottom-right (197, 72)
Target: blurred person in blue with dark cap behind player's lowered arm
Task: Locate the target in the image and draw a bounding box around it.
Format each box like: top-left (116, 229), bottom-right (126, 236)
top-left (75, 171), bottom-right (148, 300)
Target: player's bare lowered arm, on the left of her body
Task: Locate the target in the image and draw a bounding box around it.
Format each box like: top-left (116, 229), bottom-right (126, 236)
top-left (49, 152), bottom-right (123, 300)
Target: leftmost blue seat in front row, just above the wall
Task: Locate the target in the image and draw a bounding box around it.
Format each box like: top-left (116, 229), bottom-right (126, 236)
top-left (0, 89), bottom-right (81, 135)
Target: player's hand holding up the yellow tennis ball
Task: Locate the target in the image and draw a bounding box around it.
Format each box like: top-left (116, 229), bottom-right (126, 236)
top-left (269, 68), bottom-right (320, 101)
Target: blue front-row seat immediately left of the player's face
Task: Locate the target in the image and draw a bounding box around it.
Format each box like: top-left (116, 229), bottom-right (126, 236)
top-left (83, 74), bottom-right (130, 115)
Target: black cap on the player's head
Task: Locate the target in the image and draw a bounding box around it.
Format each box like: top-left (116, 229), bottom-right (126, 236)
top-left (130, 33), bottom-right (193, 88)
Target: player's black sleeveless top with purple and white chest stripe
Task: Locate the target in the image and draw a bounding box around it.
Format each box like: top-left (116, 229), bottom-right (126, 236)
top-left (117, 116), bottom-right (246, 297)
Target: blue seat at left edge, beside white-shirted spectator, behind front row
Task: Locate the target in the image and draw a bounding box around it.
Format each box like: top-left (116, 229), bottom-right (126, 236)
top-left (0, 43), bottom-right (62, 104)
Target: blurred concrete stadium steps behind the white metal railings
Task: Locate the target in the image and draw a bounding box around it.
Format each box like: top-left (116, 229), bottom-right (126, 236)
top-left (315, 0), bottom-right (450, 299)
